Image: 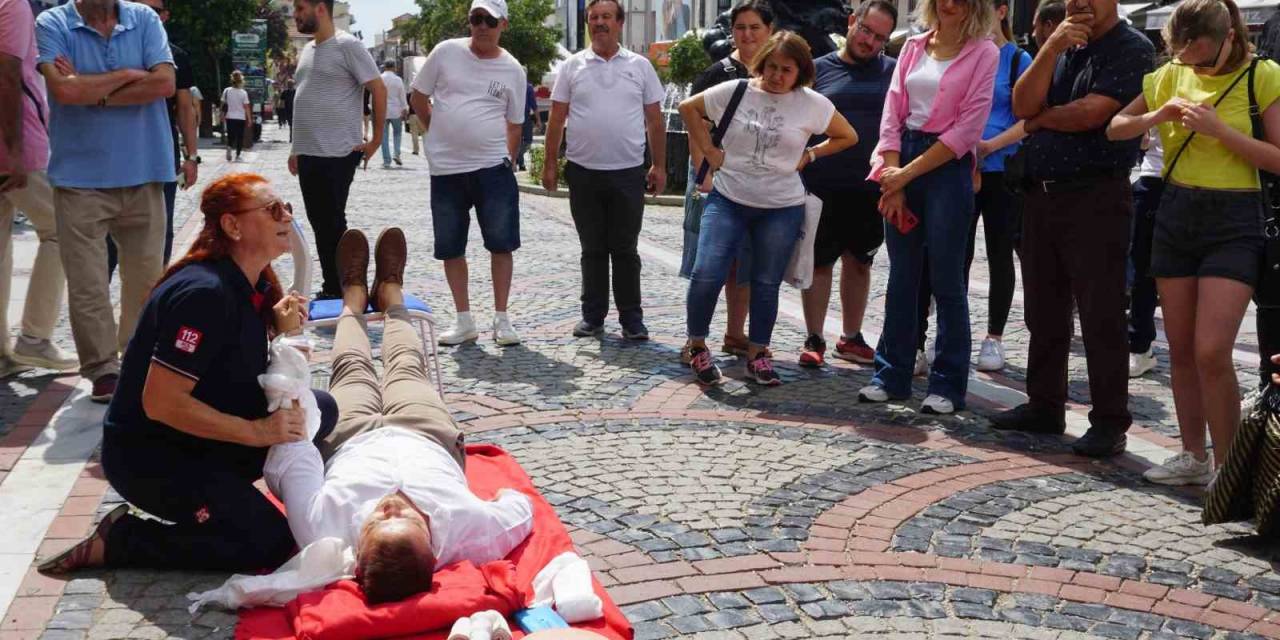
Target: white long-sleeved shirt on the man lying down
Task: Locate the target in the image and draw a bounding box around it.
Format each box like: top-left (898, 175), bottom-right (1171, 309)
top-left (264, 426), bottom-right (534, 567)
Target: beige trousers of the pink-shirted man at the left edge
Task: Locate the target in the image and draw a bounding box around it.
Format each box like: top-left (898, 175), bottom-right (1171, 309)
top-left (0, 172), bottom-right (67, 355)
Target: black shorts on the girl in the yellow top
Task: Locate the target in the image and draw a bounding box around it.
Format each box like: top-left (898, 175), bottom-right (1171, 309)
top-left (1151, 183), bottom-right (1262, 287)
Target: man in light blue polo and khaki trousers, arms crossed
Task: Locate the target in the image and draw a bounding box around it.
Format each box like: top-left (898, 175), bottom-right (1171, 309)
top-left (36, 0), bottom-right (175, 402)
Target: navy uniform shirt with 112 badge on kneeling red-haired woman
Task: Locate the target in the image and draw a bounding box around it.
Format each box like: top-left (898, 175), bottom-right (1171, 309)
top-left (104, 259), bottom-right (268, 475)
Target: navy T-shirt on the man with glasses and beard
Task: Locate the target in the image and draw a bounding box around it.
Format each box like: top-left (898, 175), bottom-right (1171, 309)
top-left (804, 51), bottom-right (897, 192)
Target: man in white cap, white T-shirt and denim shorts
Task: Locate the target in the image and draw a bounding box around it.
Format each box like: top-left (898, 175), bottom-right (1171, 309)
top-left (411, 0), bottom-right (525, 346)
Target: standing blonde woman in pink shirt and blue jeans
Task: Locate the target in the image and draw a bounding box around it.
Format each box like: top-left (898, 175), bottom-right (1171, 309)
top-left (858, 0), bottom-right (1000, 413)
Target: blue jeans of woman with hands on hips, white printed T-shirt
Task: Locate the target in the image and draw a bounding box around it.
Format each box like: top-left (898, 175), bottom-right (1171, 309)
top-left (686, 191), bottom-right (804, 347)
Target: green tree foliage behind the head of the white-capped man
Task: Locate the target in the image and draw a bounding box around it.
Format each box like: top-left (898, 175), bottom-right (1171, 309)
top-left (404, 0), bottom-right (561, 82)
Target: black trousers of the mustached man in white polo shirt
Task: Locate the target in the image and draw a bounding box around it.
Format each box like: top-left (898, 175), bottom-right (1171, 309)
top-left (564, 163), bottom-right (645, 325)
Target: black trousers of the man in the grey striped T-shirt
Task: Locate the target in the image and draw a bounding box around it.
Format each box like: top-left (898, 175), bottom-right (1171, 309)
top-left (298, 151), bottom-right (362, 297)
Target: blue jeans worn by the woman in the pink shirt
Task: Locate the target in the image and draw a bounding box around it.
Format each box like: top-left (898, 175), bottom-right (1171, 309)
top-left (872, 131), bottom-right (974, 410)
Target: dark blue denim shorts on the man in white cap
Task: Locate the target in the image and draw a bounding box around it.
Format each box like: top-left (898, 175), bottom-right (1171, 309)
top-left (431, 160), bottom-right (520, 260)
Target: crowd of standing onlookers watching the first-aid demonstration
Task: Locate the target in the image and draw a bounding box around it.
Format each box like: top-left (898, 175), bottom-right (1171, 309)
top-left (0, 0), bottom-right (1280, 484)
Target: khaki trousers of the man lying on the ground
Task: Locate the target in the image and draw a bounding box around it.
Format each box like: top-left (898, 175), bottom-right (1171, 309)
top-left (320, 305), bottom-right (466, 468)
